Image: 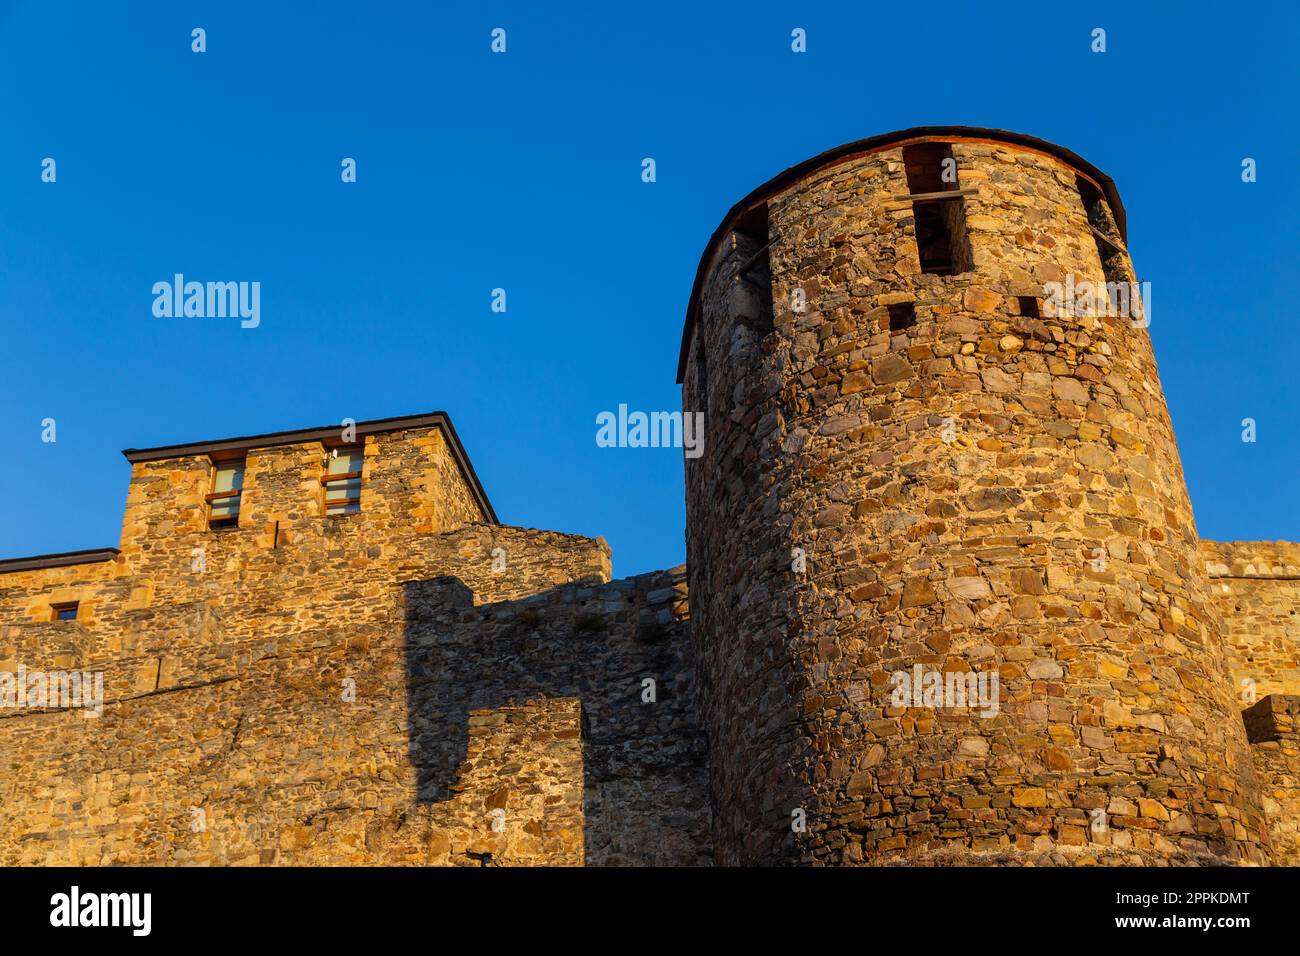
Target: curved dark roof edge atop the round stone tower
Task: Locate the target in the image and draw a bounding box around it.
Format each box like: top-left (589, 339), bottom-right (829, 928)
top-left (677, 126), bottom-right (1128, 385)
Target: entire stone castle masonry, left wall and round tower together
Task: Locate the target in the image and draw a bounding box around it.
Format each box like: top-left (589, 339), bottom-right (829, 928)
top-left (0, 131), bottom-right (1300, 866)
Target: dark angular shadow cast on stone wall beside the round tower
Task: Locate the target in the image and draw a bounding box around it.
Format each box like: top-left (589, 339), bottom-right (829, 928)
top-left (403, 574), bottom-right (711, 865)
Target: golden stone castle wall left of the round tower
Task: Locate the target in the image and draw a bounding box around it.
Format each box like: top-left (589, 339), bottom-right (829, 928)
top-left (0, 433), bottom-right (711, 865)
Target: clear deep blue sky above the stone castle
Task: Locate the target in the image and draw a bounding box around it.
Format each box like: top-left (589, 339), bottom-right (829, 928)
top-left (0, 0), bottom-right (1300, 575)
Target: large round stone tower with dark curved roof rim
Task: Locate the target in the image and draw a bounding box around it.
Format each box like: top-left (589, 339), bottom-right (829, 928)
top-left (679, 126), bottom-right (1269, 864)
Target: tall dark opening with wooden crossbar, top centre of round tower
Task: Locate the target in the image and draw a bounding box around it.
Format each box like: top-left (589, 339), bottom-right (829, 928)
top-left (902, 143), bottom-right (971, 276)
